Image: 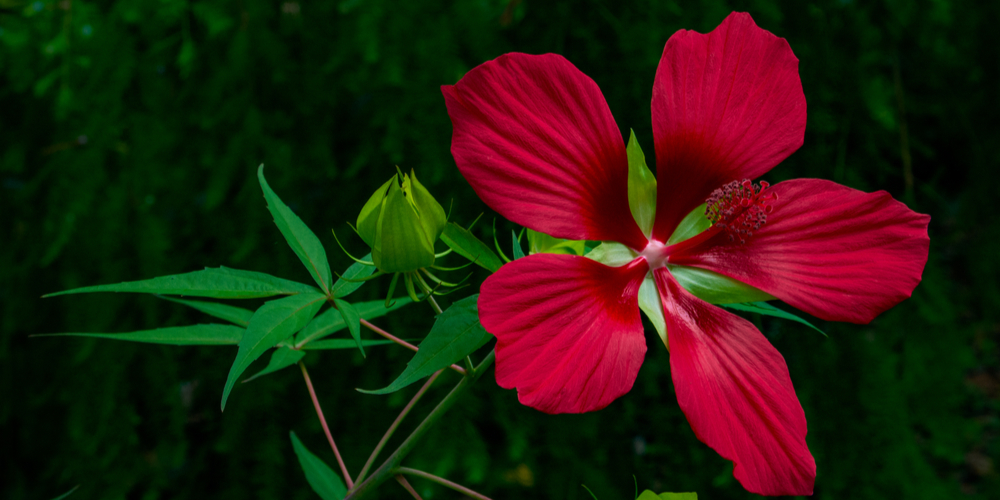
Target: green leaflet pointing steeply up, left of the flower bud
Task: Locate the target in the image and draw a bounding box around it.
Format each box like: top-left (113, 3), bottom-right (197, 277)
top-left (257, 165), bottom-right (331, 292)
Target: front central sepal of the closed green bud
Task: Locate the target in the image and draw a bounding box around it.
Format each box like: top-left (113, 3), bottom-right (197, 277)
top-left (372, 182), bottom-right (434, 273)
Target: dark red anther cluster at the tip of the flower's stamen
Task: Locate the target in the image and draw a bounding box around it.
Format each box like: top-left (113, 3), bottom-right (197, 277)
top-left (705, 179), bottom-right (778, 244)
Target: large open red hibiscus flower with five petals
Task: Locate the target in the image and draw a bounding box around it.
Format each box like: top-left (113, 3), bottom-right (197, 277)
top-left (442, 13), bottom-right (930, 495)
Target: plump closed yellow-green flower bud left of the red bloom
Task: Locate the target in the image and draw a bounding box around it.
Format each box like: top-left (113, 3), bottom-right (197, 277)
top-left (357, 170), bottom-right (448, 273)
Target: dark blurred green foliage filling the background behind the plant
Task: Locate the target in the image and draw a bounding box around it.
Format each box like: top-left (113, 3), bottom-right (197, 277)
top-left (0, 0), bottom-right (1000, 500)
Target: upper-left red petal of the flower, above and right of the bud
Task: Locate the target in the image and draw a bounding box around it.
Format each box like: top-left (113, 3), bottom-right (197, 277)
top-left (441, 53), bottom-right (646, 249)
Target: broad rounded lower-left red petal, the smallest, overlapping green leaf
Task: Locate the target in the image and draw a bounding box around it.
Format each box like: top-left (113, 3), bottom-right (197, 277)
top-left (479, 254), bottom-right (649, 413)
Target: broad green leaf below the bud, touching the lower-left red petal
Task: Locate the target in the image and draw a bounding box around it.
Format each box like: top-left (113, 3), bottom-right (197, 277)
top-left (358, 294), bottom-right (493, 394)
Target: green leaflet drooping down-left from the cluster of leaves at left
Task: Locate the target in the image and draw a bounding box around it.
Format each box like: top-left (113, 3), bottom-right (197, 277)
top-left (222, 293), bottom-right (326, 410)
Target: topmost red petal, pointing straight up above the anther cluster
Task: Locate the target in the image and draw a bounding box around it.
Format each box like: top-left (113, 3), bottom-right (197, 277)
top-left (653, 12), bottom-right (806, 241)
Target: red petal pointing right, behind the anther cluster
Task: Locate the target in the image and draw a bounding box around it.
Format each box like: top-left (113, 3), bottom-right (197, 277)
top-left (670, 179), bottom-right (930, 323)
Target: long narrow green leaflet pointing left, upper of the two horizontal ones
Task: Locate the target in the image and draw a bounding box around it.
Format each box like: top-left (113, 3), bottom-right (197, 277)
top-left (42, 267), bottom-right (317, 299)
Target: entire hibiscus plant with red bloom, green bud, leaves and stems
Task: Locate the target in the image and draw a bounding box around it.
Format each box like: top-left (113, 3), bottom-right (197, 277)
top-left (39, 13), bottom-right (929, 499)
